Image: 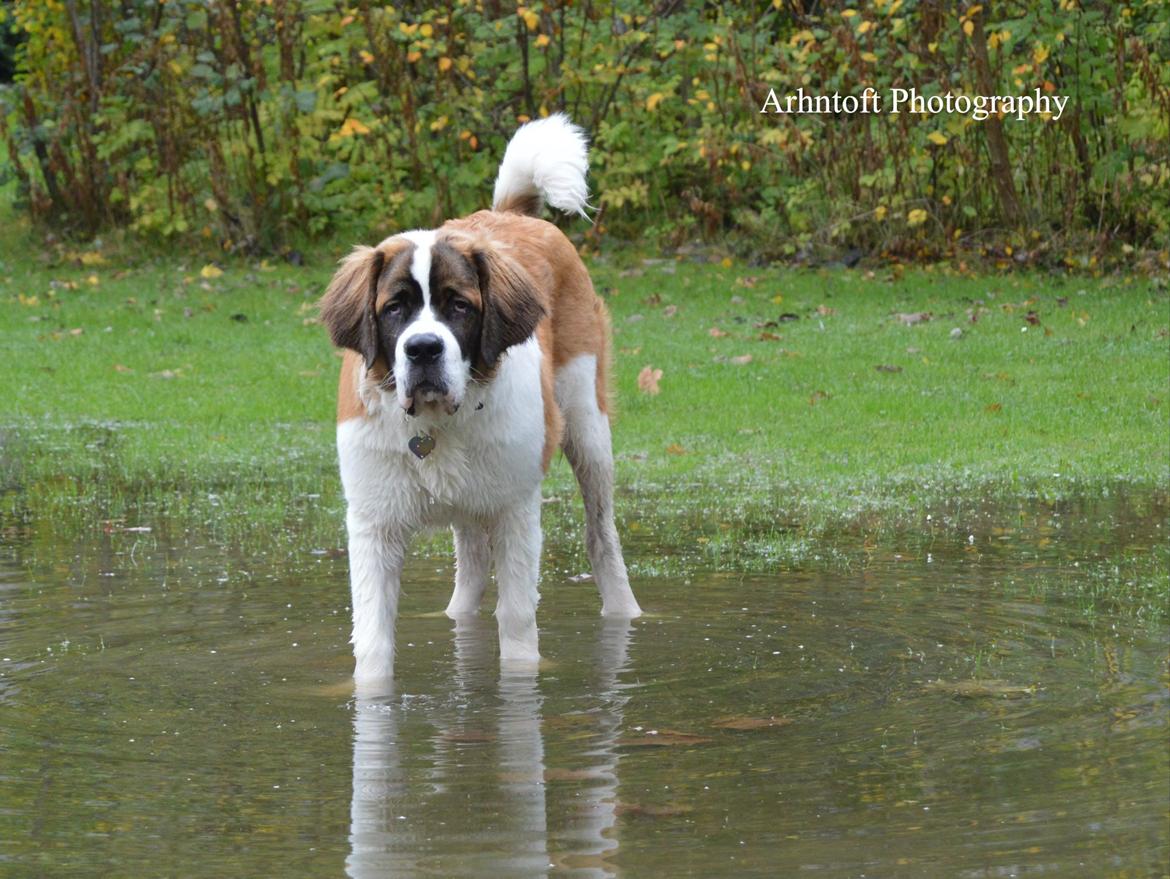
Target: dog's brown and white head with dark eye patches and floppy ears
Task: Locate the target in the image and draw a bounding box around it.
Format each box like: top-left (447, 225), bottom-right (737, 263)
top-left (321, 231), bottom-right (546, 416)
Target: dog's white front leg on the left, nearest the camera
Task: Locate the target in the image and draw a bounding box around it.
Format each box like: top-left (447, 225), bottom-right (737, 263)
top-left (346, 513), bottom-right (407, 689)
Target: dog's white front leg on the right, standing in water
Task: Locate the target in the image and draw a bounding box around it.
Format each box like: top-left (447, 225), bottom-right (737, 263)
top-left (491, 496), bottom-right (541, 665)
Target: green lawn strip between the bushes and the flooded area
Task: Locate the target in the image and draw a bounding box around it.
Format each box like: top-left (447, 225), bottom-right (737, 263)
top-left (0, 208), bottom-right (1170, 613)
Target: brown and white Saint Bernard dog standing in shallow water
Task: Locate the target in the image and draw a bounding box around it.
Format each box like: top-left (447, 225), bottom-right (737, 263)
top-left (321, 115), bottom-right (641, 687)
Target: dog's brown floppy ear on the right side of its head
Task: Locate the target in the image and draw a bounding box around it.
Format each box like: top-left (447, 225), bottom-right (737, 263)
top-left (472, 247), bottom-right (548, 370)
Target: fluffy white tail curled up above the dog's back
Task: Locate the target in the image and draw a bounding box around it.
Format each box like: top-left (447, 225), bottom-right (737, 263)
top-left (491, 114), bottom-right (589, 219)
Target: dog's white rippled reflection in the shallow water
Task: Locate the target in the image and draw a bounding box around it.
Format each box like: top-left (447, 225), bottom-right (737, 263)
top-left (346, 617), bottom-right (633, 879)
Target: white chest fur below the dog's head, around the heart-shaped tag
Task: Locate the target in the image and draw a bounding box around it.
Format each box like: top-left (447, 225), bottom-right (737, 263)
top-left (337, 338), bottom-right (544, 529)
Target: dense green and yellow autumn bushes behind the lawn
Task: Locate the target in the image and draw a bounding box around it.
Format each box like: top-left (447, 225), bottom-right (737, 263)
top-left (0, 0), bottom-right (1170, 262)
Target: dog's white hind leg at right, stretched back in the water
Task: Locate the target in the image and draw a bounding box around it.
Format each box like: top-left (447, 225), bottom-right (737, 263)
top-left (557, 355), bottom-right (642, 617)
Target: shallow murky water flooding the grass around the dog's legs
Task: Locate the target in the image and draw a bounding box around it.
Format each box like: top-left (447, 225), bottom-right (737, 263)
top-left (0, 491), bottom-right (1170, 877)
